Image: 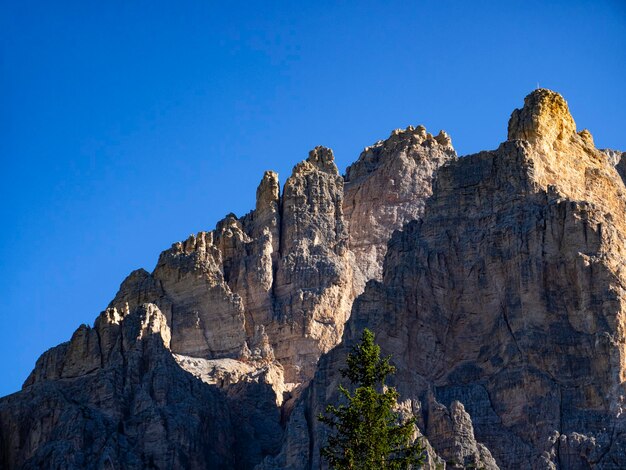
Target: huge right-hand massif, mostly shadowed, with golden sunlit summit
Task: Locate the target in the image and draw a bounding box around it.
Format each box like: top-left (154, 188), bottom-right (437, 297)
top-left (282, 90), bottom-right (626, 469)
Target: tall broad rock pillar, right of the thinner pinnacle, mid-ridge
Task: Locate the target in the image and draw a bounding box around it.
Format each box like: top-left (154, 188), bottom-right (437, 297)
top-left (270, 147), bottom-right (355, 383)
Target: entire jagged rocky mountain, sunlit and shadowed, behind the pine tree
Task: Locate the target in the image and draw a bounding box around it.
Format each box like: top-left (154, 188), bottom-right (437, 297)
top-left (0, 89), bottom-right (626, 470)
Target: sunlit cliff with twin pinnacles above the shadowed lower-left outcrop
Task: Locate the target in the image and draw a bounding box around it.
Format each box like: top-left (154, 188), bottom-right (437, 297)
top-left (101, 147), bottom-right (355, 390)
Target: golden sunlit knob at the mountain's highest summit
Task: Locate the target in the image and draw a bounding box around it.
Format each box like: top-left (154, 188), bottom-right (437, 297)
top-left (508, 88), bottom-right (576, 148)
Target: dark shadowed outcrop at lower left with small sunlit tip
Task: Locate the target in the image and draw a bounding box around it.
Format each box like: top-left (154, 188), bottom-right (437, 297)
top-left (0, 304), bottom-right (236, 469)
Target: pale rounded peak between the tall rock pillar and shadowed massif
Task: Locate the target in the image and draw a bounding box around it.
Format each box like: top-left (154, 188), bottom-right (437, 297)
top-left (343, 126), bottom-right (456, 284)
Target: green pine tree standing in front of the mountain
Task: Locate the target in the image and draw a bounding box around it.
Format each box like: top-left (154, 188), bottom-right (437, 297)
top-left (318, 329), bottom-right (424, 470)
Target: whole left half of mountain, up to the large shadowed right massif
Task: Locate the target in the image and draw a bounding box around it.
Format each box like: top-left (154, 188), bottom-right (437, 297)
top-left (0, 127), bottom-right (448, 468)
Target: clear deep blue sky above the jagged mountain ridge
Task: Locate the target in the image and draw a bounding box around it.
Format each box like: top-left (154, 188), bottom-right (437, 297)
top-left (0, 0), bottom-right (626, 395)
